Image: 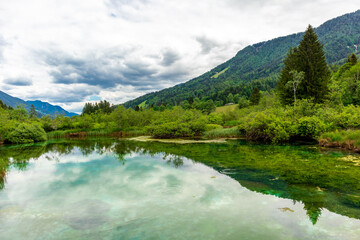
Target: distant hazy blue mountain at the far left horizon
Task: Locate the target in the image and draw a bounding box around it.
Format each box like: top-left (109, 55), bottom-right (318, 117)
top-left (0, 91), bottom-right (77, 117)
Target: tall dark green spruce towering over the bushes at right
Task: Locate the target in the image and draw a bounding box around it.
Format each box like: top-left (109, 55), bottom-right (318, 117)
top-left (278, 25), bottom-right (330, 104)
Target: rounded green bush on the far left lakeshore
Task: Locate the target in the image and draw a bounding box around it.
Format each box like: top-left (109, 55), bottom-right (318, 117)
top-left (6, 123), bottom-right (47, 143)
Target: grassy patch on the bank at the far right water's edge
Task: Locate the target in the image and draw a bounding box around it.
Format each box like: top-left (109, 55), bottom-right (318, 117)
top-left (319, 129), bottom-right (360, 147)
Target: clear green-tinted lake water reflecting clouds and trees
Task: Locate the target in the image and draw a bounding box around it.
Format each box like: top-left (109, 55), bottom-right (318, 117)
top-left (0, 139), bottom-right (360, 240)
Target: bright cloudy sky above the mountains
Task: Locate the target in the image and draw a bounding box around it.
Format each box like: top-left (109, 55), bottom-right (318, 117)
top-left (0, 0), bottom-right (360, 112)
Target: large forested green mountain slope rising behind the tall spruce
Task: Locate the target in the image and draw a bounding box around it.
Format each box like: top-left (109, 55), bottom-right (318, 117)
top-left (124, 10), bottom-right (360, 108)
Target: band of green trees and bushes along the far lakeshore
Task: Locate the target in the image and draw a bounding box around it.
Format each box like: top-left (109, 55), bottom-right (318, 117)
top-left (0, 26), bottom-right (360, 148)
